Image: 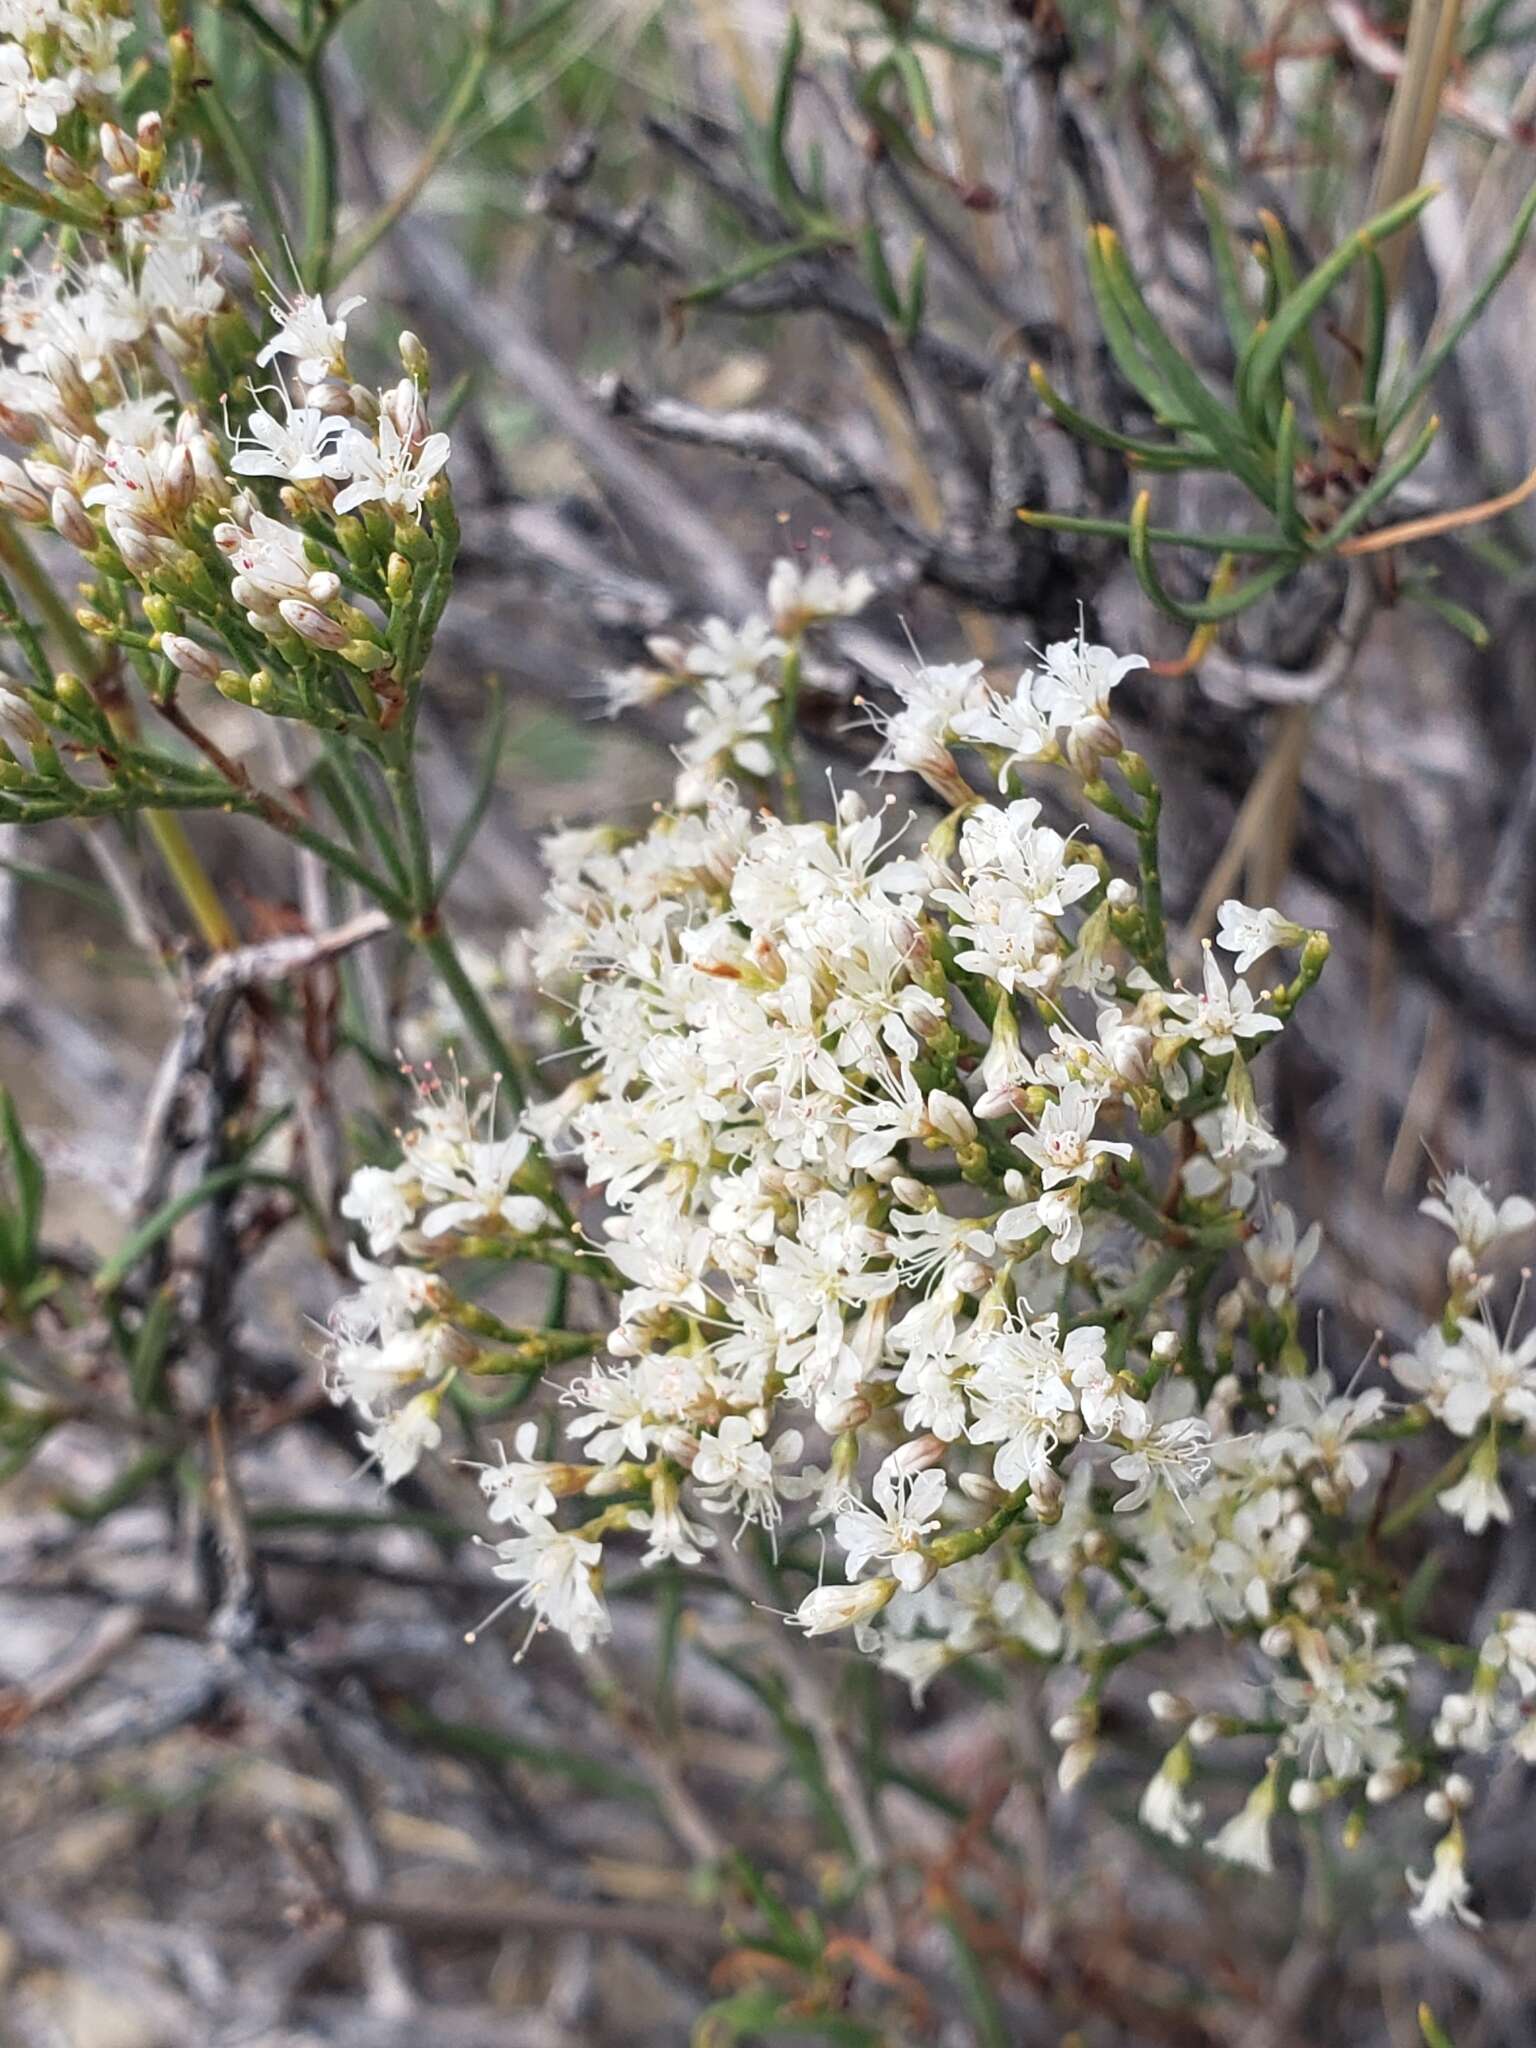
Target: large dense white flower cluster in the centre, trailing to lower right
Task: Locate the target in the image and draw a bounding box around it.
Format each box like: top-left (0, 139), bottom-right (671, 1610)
top-left (334, 563), bottom-right (1536, 1919)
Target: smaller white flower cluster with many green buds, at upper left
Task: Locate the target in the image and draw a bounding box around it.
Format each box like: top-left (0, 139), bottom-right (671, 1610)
top-left (0, 36), bottom-right (457, 821)
